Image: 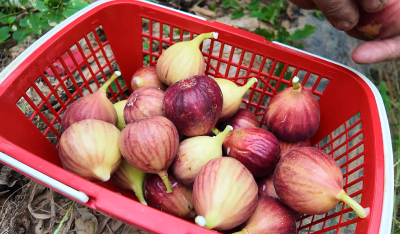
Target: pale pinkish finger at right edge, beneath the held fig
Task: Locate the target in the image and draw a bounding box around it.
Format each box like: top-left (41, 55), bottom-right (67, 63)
top-left (351, 36), bottom-right (400, 64)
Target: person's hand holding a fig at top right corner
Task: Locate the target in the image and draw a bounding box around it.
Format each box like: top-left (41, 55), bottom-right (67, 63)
top-left (290, 0), bottom-right (400, 63)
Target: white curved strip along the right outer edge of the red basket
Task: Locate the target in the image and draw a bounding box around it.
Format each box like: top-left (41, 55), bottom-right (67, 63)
top-left (273, 41), bottom-right (394, 234)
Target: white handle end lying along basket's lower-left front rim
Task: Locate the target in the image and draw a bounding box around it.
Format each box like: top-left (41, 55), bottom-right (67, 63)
top-left (0, 152), bottom-right (89, 203)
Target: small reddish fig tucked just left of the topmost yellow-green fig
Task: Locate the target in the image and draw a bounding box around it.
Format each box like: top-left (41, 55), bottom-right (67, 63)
top-left (131, 66), bottom-right (168, 91)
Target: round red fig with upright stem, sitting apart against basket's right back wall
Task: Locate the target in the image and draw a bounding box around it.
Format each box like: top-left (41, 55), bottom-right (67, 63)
top-left (265, 76), bottom-right (320, 142)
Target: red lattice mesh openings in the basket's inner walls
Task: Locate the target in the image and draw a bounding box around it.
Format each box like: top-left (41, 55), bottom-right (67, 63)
top-left (8, 7), bottom-right (372, 233)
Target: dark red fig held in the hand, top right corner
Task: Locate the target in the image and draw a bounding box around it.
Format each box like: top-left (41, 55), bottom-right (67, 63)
top-left (356, 0), bottom-right (400, 39)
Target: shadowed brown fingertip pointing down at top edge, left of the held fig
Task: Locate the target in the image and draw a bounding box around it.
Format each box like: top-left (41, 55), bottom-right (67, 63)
top-left (314, 0), bottom-right (359, 31)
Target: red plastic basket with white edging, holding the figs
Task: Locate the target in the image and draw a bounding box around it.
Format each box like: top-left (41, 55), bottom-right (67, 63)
top-left (0, 0), bottom-right (394, 234)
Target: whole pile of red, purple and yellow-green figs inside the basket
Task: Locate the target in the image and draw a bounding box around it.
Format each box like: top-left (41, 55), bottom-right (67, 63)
top-left (59, 33), bottom-right (368, 234)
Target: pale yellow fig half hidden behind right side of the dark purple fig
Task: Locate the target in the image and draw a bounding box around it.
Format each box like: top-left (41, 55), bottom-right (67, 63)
top-left (215, 77), bottom-right (258, 122)
